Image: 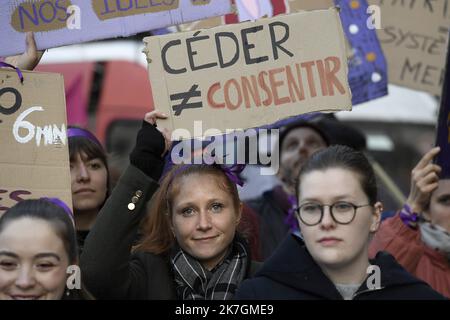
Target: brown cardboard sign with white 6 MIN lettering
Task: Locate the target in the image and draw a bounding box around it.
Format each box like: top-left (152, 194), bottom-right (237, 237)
top-left (0, 68), bottom-right (72, 215)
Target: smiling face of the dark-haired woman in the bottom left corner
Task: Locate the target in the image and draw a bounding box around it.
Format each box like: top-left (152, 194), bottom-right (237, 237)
top-left (0, 218), bottom-right (69, 300)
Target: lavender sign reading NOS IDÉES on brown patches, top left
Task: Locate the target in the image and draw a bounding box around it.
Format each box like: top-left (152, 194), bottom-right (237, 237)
top-left (0, 0), bottom-right (231, 57)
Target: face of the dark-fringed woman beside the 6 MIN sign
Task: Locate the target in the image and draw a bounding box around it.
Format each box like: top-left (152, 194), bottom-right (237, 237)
top-left (70, 152), bottom-right (108, 211)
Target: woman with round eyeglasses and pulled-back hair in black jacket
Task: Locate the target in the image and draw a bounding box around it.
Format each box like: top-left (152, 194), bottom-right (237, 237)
top-left (236, 146), bottom-right (443, 300)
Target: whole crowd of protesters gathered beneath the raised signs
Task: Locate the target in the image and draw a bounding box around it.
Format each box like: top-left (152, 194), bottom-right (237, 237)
top-left (0, 34), bottom-right (450, 300)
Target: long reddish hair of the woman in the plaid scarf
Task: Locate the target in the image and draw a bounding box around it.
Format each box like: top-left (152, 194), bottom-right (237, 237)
top-left (134, 164), bottom-right (241, 254)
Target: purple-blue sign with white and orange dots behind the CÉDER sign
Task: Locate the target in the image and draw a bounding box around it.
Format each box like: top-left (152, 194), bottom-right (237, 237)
top-left (335, 0), bottom-right (388, 105)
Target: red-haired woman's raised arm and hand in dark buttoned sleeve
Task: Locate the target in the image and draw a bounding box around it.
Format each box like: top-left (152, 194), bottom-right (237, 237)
top-left (81, 111), bottom-right (170, 299)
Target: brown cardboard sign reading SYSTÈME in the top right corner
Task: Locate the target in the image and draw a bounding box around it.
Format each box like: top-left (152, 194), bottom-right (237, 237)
top-left (369, 0), bottom-right (450, 95)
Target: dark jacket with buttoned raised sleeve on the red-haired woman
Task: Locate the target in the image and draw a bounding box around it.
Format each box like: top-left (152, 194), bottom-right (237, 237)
top-left (80, 165), bottom-right (259, 300)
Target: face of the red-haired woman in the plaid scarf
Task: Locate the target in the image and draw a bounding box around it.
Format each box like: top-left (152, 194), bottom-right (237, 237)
top-left (172, 174), bottom-right (241, 269)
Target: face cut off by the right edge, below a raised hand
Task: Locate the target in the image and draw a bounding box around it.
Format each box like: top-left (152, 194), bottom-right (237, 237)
top-left (428, 179), bottom-right (450, 232)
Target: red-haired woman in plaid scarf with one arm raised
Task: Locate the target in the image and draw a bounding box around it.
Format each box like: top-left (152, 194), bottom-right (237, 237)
top-left (81, 111), bottom-right (257, 300)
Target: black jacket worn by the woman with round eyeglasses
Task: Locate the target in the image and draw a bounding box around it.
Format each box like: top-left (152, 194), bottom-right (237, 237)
top-left (235, 235), bottom-right (445, 300)
